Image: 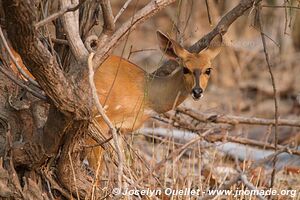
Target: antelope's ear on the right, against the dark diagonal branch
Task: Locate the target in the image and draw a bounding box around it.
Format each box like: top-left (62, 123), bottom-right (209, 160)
top-left (199, 34), bottom-right (223, 60)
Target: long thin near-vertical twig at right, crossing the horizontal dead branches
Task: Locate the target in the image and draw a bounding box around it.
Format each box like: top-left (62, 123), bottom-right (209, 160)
top-left (257, 7), bottom-right (278, 188)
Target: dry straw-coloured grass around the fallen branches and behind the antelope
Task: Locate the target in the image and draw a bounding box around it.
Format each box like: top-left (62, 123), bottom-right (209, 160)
top-left (91, 1), bottom-right (300, 199)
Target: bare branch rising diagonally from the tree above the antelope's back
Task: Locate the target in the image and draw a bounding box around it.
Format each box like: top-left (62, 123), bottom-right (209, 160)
top-left (93, 0), bottom-right (175, 69)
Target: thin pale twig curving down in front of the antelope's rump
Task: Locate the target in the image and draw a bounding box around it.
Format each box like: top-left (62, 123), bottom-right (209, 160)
top-left (88, 53), bottom-right (124, 191)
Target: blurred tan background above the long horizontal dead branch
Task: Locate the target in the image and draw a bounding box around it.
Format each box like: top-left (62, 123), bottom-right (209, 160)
top-left (111, 0), bottom-right (300, 144)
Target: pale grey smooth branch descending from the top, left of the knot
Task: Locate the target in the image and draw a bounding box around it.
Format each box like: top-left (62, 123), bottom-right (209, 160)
top-left (60, 0), bottom-right (88, 62)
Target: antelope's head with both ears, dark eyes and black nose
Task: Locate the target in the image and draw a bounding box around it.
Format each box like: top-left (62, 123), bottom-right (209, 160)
top-left (157, 31), bottom-right (222, 100)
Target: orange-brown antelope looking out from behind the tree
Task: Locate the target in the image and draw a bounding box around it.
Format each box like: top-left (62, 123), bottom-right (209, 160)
top-left (87, 31), bottom-right (222, 169)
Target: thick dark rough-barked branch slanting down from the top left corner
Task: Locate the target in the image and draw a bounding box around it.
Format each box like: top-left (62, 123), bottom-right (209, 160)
top-left (3, 0), bottom-right (79, 114)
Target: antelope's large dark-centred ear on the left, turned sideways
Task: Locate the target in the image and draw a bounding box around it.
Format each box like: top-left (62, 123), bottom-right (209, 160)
top-left (156, 31), bottom-right (190, 60)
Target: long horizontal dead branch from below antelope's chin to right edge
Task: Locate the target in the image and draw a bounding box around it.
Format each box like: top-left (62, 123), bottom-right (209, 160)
top-left (176, 108), bottom-right (300, 127)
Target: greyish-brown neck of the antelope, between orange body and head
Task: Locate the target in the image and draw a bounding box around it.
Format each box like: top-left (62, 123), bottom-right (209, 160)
top-left (145, 68), bottom-right (191, 113)
